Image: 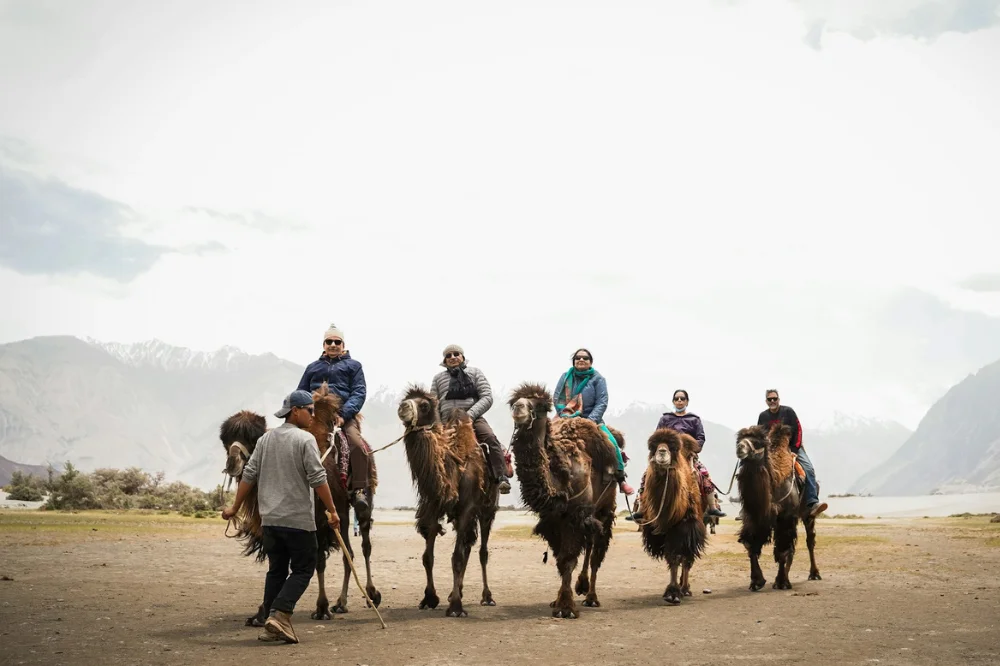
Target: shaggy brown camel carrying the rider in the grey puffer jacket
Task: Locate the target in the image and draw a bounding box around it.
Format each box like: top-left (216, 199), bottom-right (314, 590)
top-left (397, 386), bottom-right (499, 617)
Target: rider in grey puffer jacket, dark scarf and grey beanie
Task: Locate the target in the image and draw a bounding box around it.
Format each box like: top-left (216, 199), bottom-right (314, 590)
top-left (431, 345), bottom-right (510, 495)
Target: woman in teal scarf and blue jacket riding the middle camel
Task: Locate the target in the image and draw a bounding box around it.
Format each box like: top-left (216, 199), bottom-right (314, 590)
top-left (552, 348), bottom-right (635, 495)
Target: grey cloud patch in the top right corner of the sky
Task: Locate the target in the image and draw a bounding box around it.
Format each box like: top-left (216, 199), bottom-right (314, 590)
top-left (797, 0), bottom-right (1000, 50)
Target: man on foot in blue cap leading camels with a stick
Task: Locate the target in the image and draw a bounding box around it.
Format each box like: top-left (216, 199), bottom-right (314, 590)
top-left (222, 391), bottom-right (340, 643)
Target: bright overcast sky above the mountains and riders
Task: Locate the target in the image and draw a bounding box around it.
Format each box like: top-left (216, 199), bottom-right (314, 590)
top-left (0, 0), bottom-right (1000, 427)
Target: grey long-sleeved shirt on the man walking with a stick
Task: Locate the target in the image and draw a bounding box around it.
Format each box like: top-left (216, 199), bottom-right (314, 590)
top-left (242, 423), bottom-right (326, 532)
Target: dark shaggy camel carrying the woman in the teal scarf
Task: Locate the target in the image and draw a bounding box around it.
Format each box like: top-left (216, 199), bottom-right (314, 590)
top-left (509, 383), bottom-right (625, 619)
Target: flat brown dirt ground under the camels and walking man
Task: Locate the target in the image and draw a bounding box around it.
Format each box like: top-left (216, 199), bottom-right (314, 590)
top-left (0, 511), bottom-right (1000, 666)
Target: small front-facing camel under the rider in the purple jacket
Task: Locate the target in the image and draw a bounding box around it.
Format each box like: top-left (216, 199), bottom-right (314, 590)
top-left (641, 428), bottom-right (707, 605)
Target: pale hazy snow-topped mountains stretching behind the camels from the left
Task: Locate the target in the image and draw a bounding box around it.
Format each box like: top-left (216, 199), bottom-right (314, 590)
top-left (0, 336), bottom-right (932, 506)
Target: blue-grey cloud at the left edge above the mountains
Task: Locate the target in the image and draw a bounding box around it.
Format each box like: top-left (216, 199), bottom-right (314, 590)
top-left (0, 166), bottom-right (221, 283)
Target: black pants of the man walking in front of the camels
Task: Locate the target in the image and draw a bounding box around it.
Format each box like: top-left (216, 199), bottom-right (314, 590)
top-left (264, 525), bottom-right (316, 614)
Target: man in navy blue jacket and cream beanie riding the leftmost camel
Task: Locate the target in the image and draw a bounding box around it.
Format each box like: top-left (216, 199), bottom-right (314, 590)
top-left (298, 324), bottom-right (371, 522)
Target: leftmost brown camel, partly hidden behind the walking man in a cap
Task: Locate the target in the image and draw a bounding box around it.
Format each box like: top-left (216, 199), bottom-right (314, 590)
top-left (219, 383), bottom-right (382, 627)
